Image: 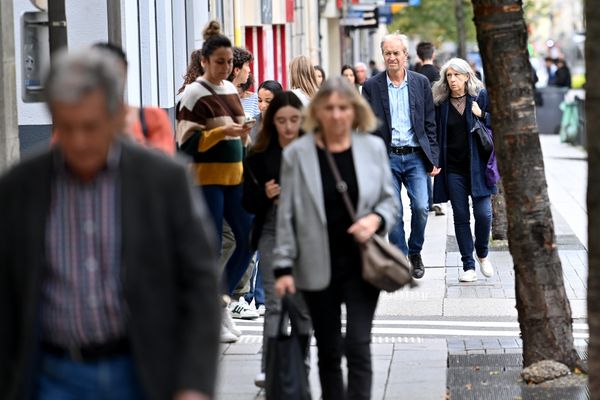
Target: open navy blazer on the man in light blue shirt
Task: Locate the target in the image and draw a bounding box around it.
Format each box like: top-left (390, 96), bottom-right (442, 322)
top-left (362, 70), bottom-right (439, 171)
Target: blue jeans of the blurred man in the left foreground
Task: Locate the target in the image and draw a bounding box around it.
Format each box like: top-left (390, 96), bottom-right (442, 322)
top-left (34, 353), bottom-right (145, 400)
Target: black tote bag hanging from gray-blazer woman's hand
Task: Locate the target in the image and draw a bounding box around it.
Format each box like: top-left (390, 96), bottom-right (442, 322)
top-left (265, 295), bottom-right (311, 400)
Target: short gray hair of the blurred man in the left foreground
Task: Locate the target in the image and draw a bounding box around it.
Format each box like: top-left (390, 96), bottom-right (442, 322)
top-left (45, 48), bottom-right (125, 115)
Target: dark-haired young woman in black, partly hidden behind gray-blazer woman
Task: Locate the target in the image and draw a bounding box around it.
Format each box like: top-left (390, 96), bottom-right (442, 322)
top-left (243, 91), bottom-right (310, 387)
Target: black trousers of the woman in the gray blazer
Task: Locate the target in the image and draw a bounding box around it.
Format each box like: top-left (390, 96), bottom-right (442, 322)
top-left (302, 274), bottom-right (379, 400)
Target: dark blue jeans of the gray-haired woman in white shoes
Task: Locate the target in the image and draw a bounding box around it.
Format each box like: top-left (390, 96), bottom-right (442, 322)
top-left (448, 172), bottom-right (492, 271)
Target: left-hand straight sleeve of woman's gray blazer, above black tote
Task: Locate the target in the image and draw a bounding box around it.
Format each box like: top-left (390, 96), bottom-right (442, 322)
top-left (273, 145), bottom-right (298, 268)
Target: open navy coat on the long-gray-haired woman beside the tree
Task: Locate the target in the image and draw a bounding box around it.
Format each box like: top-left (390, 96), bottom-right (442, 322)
top-left (433, 89), bottom-right (498, 203)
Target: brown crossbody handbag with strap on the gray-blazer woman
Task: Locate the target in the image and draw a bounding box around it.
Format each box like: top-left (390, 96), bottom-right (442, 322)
top-left (321, 135), bottom-right (416, 292)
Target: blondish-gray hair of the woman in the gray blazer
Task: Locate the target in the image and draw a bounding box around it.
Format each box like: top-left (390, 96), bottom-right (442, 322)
top-left (303, 76), bottom-right (377, 132)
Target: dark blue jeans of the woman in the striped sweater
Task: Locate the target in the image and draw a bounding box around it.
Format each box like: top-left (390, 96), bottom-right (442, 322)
top-left (200, 185), bottom-right (253, 295)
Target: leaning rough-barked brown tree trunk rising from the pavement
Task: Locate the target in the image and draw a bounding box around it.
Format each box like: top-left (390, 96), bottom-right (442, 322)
top-left (472, 0), bottom-right (579, 368)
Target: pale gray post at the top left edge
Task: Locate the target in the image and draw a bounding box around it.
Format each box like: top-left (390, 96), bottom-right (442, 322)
top-left (0, 1), bottom-right (19, 172)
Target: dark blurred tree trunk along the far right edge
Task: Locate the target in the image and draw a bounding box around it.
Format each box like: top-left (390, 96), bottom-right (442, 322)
top-left (585, 0), bottom-right (600, 400)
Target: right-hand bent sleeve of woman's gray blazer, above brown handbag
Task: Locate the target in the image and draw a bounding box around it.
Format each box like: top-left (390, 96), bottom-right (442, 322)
top-left (373, 141), bottom-right (400, 234)
